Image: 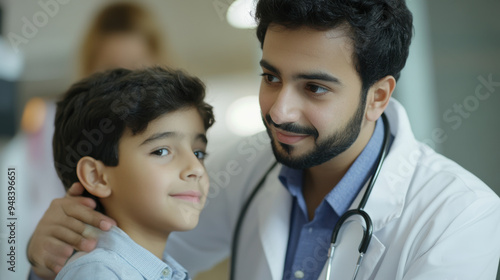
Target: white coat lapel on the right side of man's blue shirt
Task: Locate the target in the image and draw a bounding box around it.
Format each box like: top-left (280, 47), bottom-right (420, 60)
top-left (320, 99), bottom-right (420, 280)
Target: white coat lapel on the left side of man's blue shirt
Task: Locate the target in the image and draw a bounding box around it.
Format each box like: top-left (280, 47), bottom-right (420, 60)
top-left (258, 168), bottom-right (292, 280)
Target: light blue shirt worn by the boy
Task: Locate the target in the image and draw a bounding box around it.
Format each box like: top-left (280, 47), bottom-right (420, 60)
top-left (56, 227), bottom-right (190, 280)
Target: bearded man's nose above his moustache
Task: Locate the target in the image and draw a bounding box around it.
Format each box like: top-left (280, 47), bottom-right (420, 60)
top-left (269, 87), bottom-right (302, 124)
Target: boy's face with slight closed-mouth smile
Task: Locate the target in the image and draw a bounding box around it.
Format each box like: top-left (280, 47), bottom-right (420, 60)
top-left (101, 108), bottom-right (209, 237)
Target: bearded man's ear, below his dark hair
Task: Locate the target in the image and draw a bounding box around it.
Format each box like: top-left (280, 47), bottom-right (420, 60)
top-left (366, 75), bottom-right (396, 121)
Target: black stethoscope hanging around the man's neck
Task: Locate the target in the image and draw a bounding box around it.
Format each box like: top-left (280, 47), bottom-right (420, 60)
top-left (229, 114), bottom-right (391, 280)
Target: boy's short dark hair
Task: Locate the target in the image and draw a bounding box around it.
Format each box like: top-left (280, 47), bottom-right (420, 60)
top-left (52, 67), bottom-right (214, 211)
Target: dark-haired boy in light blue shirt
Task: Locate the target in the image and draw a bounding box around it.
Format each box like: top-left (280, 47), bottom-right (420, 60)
top-left (53, 67), bottom-right (214, 280)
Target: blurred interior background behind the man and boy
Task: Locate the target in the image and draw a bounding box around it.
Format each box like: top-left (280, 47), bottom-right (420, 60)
top-left (0, 0), bottom-right (500, 279)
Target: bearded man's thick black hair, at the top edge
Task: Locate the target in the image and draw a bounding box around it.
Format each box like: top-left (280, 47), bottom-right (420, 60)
top-left (255, 0), bottom-right (413, 97)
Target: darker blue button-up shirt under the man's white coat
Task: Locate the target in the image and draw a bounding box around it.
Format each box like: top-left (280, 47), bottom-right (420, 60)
top-left (279, 119), bottom-right (384, 280)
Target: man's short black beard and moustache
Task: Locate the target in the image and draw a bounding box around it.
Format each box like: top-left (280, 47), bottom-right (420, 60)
top-left (263, 99), bottom-right (365, 169)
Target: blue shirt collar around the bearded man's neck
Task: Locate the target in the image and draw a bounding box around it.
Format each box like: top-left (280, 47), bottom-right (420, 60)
top-left (278, 119), bottom-right (384, 216)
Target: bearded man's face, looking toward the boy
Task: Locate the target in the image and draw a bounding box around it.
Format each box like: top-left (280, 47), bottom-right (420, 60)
top-left (259, 25), bottom-right (365, 169)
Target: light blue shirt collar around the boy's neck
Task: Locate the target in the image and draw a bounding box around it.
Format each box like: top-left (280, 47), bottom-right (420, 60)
top-left (98, 226), bottom-right (189, 280)
